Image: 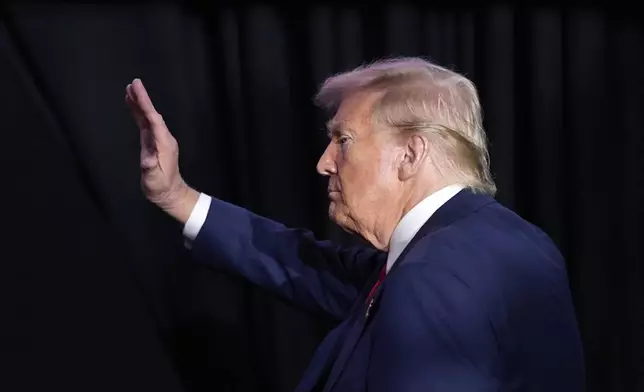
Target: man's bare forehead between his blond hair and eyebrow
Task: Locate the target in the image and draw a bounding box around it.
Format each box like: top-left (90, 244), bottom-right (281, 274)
top-left (327, 92), bottom-right (377, 135)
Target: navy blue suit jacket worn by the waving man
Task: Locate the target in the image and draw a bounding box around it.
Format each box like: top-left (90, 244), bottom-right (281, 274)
top-left (193, 190), bottom-right (585, 392)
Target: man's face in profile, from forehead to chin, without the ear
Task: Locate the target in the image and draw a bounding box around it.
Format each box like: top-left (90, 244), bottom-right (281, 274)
top-left (317, 93), bottom-right (401, 245)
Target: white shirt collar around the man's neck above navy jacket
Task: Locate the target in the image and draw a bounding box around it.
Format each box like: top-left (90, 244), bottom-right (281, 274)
top-left (387, 184), bottom-right (465, 272)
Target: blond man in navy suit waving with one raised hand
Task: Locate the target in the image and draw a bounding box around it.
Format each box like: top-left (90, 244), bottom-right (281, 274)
top-left (126, 58), bottom-right (584, 392)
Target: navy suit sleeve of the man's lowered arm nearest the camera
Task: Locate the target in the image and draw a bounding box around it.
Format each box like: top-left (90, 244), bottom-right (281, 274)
top-left (368, 264), bottom-right (499, 392)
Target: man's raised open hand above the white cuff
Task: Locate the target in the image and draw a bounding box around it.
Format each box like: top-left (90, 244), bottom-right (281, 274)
top-left (125, 79), bottom-right (198, 221)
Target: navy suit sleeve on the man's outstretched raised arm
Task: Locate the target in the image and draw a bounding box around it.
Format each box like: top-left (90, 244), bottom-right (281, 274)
top-left (190, 194), bottom-right (386, 319)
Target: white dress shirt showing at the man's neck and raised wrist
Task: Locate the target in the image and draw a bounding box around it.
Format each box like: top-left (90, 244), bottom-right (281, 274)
top-left (183, 185), bottom-right (464, 272)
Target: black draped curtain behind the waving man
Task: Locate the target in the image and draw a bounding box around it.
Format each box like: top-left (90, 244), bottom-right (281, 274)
top-left (0, 3), bottom-right (644, 392)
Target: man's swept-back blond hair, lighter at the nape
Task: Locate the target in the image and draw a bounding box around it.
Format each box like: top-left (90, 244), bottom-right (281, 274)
top-left (316, 58), bottom-right (496, 195)
